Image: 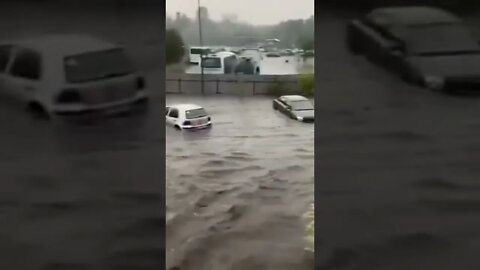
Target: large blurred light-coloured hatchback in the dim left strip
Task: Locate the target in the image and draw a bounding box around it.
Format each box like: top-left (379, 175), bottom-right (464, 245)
top-left (0, 34), bottom-right (148, 118)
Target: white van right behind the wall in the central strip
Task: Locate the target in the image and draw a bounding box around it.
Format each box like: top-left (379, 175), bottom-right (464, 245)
top-left (201, 52), bottom-right (238, 74)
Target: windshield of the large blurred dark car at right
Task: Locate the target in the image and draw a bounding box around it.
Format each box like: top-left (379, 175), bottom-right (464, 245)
top-left (393, 23), bottom-right (480, 55)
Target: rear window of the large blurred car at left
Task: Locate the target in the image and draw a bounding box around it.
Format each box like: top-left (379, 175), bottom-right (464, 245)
top-left (64, 48), bottom-right (136, 83)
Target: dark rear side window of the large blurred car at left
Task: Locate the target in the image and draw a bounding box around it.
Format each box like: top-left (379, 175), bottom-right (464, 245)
top-left (10, 50), bottom-right (41, 80)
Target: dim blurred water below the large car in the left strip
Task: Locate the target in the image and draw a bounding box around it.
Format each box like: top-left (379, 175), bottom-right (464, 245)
top-left (0, 90), bottom-right (165, 270)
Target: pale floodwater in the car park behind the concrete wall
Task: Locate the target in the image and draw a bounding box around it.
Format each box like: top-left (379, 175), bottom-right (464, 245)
top-left (185, 55), bottom-right (314, 75)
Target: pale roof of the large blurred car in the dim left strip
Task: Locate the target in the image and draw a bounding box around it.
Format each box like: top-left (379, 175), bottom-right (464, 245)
top-left (2, 34), bottom-right (120, 57)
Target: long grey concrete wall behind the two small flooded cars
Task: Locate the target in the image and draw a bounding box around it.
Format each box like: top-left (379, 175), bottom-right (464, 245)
top-left (165, 73), bottom-right (300, 95)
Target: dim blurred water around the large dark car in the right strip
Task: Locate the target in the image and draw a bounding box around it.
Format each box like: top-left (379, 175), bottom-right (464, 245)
top-left (315, 11), bottom-right (480, 270)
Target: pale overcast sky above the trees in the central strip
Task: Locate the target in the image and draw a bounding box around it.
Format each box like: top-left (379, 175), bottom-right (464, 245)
top-left (167, 0), bottom-right (314, 25)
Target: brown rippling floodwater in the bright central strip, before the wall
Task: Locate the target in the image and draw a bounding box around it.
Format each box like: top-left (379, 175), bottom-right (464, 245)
top-left (166, 95), bottom-right (314, 270)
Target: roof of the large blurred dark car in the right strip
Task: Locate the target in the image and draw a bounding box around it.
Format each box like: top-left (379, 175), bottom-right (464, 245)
top-left (369, 6), bottom-right (461, 26)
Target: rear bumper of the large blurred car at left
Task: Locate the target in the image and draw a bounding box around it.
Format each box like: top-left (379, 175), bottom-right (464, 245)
top-left (53, 95), bottom-right (148, 116)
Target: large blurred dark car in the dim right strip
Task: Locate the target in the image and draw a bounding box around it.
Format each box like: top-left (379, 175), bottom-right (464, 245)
top-left (346, 7), bottom-right (480, 92)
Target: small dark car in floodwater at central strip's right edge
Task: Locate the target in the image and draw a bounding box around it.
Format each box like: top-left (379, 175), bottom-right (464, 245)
top-left (273, 95), bottom-right (315, 123)
